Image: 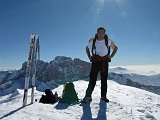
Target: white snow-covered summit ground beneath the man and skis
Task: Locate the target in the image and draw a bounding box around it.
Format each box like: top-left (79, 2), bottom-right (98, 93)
top-left (0, 80), bottom-right (160, 120)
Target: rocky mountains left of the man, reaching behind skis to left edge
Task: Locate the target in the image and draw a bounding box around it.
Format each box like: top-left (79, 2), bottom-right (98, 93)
top-left (0, 56), bottom-right (90, 95)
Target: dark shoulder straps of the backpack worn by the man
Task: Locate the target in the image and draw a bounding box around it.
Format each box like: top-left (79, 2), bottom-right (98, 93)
top-left (92, 34), bottom-right (110, 56)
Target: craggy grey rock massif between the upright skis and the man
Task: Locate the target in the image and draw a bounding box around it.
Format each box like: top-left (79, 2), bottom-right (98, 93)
top-left (22, 56), bottom-right (90, 82)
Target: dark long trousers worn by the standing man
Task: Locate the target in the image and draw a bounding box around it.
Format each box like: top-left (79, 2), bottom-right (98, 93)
top-left (85, 61), bottom-right (109, 97)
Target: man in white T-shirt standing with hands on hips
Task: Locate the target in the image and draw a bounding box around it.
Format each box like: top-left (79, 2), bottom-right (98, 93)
top-left (82, 27), bottom-right (118, 102)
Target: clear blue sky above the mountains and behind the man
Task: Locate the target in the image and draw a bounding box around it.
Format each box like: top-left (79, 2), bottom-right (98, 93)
top-left (0, 0), bottom-right (160, 69)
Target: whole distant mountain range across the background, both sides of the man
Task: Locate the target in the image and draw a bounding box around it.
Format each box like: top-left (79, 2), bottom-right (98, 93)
top-left (0, 56), bottom-right (160, 95)
